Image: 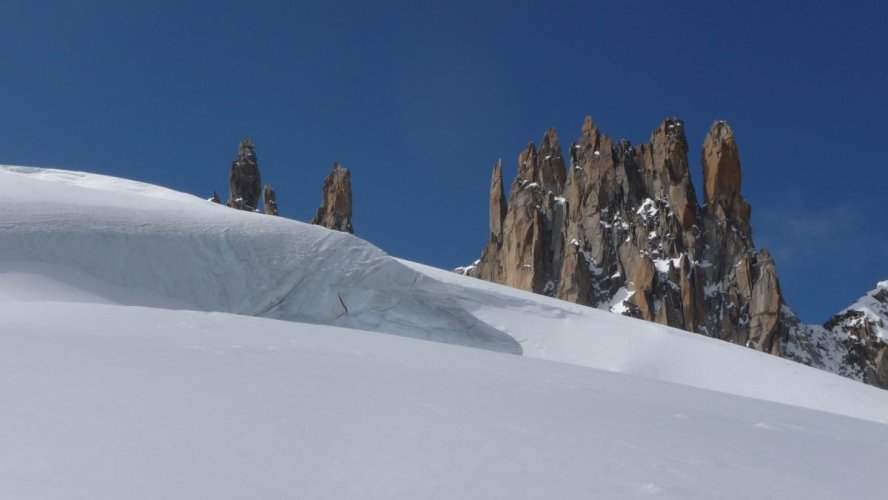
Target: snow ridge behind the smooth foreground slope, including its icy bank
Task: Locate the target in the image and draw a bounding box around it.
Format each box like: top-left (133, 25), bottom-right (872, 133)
top-left (0, 167), bottom-right (888, 422)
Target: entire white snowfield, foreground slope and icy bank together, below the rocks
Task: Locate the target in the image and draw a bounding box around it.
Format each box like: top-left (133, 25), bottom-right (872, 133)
top-left (0, 167), bottom-right (888, 499)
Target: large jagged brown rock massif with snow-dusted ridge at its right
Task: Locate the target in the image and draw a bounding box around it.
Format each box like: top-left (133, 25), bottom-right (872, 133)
top-left (457, 117), bottom-right (888, 387)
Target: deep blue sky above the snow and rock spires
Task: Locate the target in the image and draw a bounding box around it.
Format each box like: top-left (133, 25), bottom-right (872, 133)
top-left (0, 0), bottom-right (888, 322)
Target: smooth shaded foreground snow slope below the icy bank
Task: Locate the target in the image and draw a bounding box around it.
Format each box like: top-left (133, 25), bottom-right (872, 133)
top-left (0, 301), bottom-right (888, 500)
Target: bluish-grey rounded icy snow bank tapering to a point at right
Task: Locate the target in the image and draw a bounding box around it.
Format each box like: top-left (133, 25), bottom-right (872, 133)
top-left (0, 167), bottom-right (521, 353)
